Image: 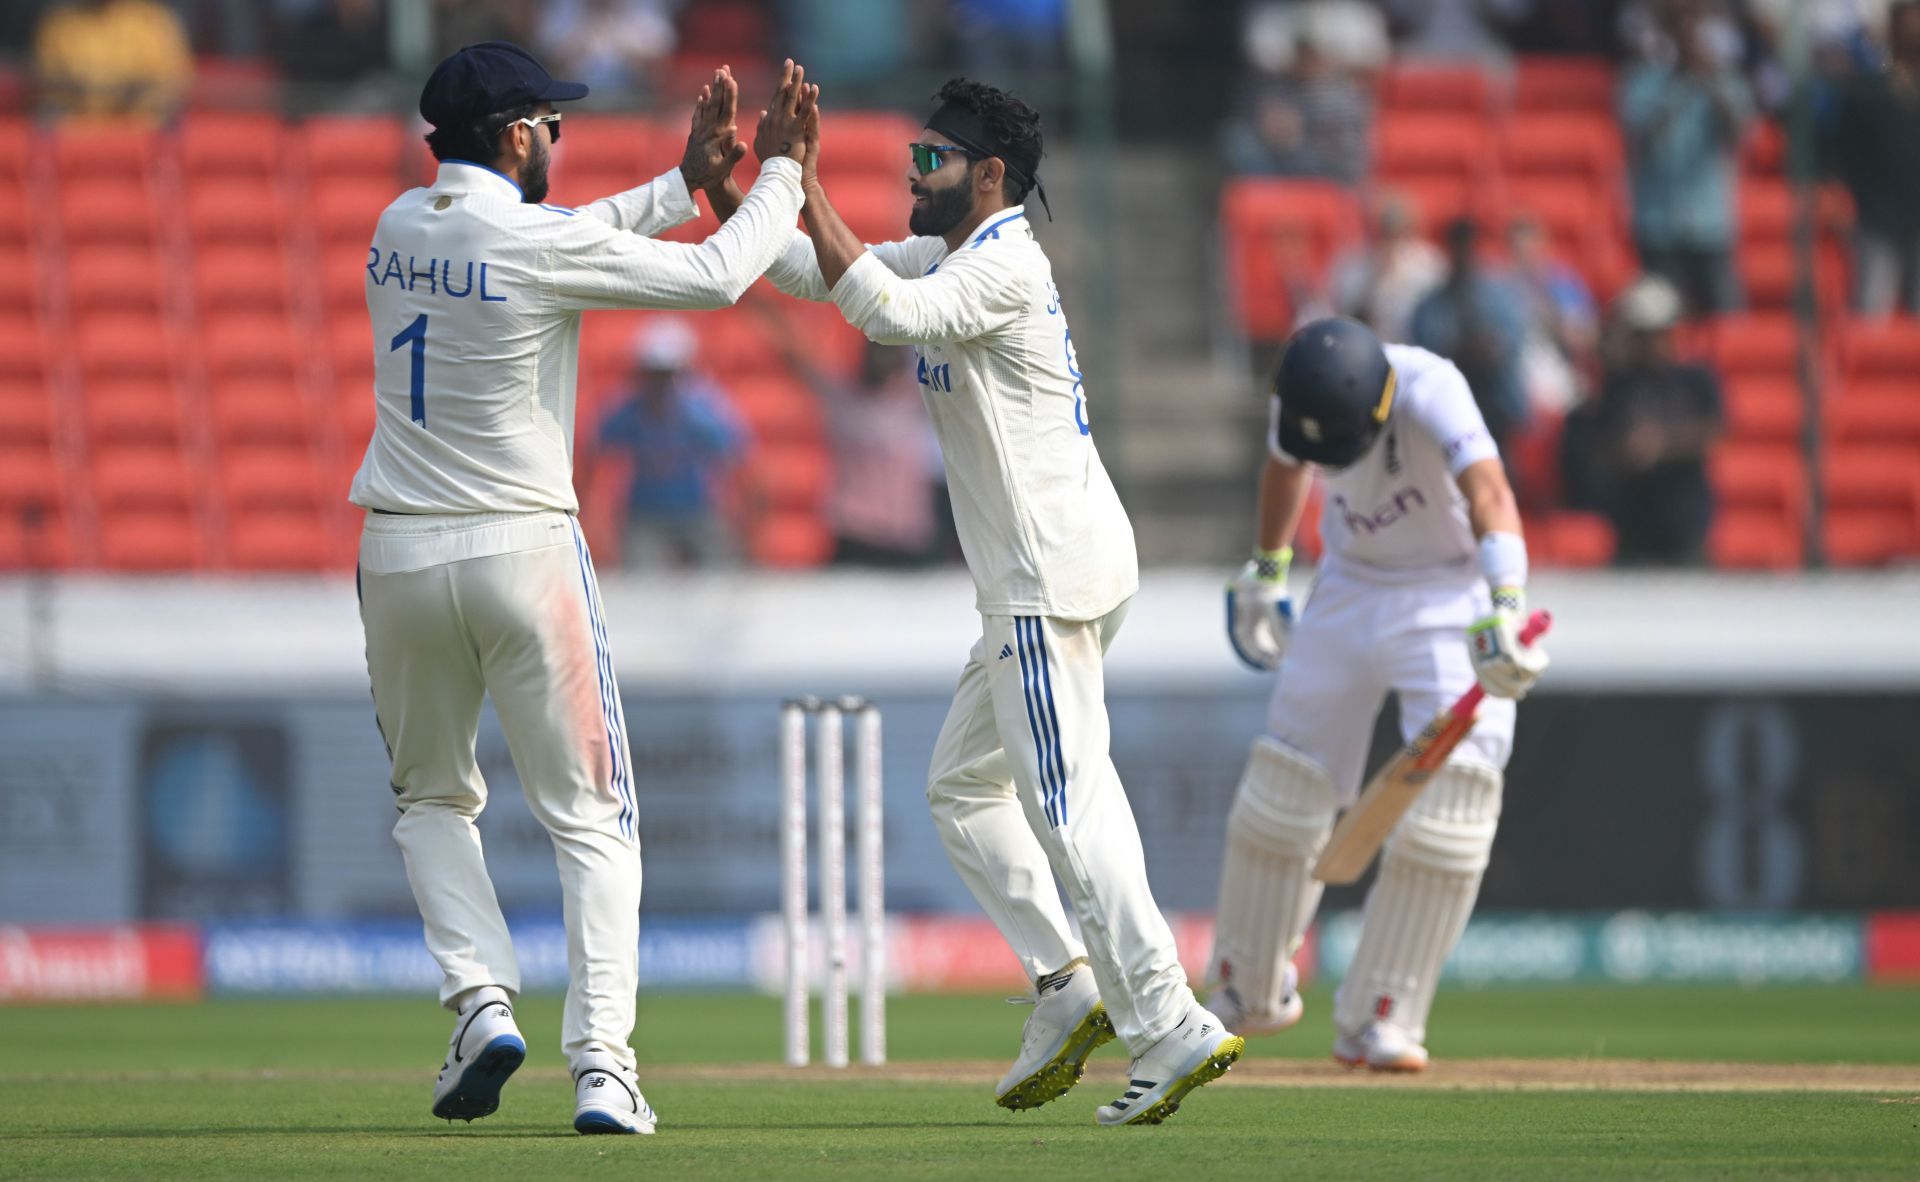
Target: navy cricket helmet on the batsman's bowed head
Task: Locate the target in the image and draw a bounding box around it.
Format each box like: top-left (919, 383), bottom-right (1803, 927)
top-left (1273, 317), bottom-right (1394, 468)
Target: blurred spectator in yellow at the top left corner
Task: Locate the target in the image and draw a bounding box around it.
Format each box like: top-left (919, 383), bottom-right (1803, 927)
top-left (33, 0), bottom-right (194, 125)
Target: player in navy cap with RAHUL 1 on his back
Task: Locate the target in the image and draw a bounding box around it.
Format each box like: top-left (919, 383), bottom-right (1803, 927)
top-left (351, 42), bottom-right (810, 1132)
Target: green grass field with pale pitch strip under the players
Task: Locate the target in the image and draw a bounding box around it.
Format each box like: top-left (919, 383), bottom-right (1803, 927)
top-left (0, 988), bottom-right (1920, 1182)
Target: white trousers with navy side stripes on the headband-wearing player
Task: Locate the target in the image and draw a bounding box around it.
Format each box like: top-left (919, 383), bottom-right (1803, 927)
top-left (927, 604), bottom-right (1194, 1055)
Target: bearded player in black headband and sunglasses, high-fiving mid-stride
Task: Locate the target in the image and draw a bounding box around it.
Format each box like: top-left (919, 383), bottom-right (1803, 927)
top-left (691, 81), bottom-right (1242, 1124)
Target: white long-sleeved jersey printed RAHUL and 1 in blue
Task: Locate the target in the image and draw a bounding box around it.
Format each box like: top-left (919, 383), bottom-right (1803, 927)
top-left (349, 159), bottom-right (801, 521)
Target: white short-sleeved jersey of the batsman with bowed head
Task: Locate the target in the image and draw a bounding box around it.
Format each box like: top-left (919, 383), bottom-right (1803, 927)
top-left (1267, 345), bottom-right (1500, 583)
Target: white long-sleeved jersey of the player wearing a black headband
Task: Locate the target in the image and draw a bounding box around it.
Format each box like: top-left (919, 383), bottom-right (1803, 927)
top-left (766, 205), bottom-right (1140, 620)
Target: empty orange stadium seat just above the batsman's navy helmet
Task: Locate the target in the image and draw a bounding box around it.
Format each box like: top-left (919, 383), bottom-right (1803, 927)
top-left (1221, 178), bottom-right (1361, 340)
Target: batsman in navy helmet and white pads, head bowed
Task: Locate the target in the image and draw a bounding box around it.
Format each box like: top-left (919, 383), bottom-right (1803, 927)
top-left (1208, 319), bottom-right (1548, 1071)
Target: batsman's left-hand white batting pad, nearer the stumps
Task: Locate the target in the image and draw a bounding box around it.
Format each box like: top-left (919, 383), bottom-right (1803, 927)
top-left (1208, 737), bottom-right (1336, 1021)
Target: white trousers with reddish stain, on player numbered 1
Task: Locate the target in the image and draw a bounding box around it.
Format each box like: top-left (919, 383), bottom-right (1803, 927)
top-left (359, 512), bottom-right (639, 1069)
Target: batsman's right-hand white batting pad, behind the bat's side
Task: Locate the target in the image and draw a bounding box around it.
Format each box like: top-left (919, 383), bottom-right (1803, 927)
top-left (1332, 762), bottom-right (1501, 1042)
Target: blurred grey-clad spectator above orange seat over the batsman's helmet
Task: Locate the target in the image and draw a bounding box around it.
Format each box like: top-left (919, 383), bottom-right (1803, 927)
top-left (1225, 6), bottom-right (1373, 184)
